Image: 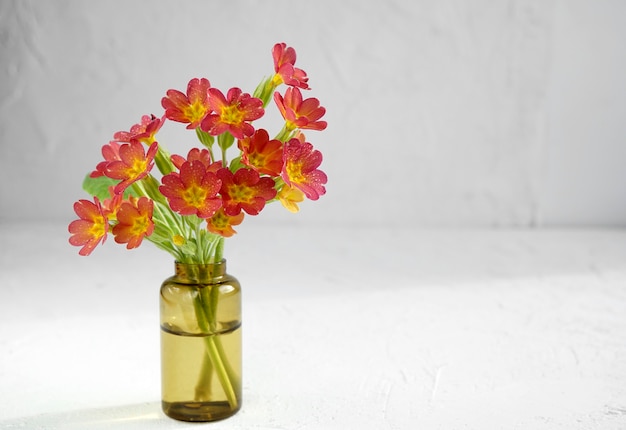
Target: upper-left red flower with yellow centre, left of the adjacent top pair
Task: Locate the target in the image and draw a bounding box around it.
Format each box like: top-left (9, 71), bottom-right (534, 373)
top-left (161, 78), bottom-right (211, 129)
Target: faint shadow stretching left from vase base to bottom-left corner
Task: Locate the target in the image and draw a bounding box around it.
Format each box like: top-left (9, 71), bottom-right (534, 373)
top-left (0, 402), bottom-right (176, 430)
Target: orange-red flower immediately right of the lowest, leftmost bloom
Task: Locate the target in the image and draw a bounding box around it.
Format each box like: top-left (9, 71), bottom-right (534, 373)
top-left (113, 197), bottom-right (154, 249)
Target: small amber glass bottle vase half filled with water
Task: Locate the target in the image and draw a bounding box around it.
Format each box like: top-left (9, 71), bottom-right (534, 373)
top-left (160, 260), bottom-right (241, 421)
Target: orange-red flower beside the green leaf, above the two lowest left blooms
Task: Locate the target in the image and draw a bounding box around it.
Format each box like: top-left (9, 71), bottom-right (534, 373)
top-left (103, 140), bottom-right (158, 194)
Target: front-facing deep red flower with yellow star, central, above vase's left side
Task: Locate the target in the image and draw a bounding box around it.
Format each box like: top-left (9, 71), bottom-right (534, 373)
top-left (159, 160), bottom-right (222, 218)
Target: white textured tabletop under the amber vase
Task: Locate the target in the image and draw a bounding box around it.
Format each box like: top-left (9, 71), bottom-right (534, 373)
top-left (0, 223), bottom-right (626, 430)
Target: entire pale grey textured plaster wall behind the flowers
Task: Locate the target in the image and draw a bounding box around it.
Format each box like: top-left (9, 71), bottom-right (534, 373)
top-left (0, 0), bottom-right (626, 226)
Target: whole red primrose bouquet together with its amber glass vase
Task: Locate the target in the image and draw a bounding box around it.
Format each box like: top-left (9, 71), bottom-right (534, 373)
top-left (68, 43), bottom-right (327, 420)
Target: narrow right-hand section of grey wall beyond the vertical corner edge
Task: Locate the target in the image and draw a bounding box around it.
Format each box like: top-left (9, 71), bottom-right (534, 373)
top-left (540, 0), bottom-right (626, 226)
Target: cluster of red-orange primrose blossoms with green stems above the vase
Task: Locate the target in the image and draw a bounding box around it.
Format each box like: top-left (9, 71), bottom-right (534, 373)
top-left (69, 43), bottom-right (327, 255)
